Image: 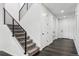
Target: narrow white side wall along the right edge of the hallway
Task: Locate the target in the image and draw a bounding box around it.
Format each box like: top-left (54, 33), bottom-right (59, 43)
top-left (74, 4), bottom-right (79, 55)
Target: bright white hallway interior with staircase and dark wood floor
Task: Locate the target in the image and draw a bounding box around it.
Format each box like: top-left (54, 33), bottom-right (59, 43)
top-left (0, 3), bottom-right (79, 56)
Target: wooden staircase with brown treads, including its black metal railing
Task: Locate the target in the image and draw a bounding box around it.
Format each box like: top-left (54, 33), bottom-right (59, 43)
top-left (4, 8), bottom-right (39, 56)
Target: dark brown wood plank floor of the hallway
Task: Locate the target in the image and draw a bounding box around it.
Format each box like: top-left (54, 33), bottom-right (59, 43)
top-left (37, 38), bottom-right (78, 56)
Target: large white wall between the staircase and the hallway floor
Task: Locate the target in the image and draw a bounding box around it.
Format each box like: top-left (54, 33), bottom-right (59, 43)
top-left (20, 4), bottom-right (55, 49)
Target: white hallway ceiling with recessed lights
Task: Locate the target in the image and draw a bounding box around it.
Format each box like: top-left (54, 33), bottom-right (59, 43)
top-left (44, 3), bottom-right (77, 18)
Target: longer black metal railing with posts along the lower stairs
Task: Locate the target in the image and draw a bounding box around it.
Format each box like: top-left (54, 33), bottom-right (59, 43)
top-left (3, 8), bottom-right (27, 54)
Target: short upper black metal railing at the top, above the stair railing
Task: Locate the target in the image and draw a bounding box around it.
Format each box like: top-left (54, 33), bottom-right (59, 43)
top-left (19, 3), bottom-right (32, 21)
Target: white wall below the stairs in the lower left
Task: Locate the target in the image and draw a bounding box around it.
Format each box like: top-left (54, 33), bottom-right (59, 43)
top-left (0, 25), bottom-right (24, 56)
